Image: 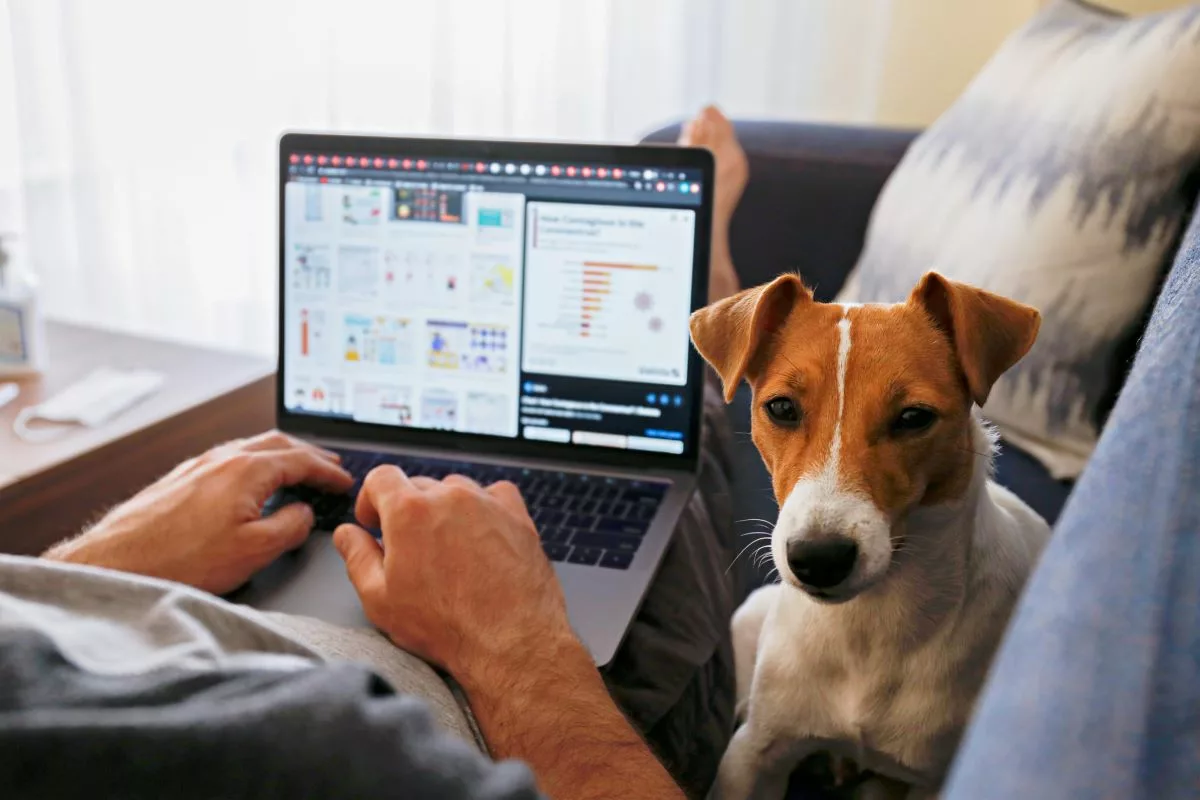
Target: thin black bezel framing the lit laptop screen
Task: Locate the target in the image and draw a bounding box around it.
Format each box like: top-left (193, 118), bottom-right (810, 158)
top-left (275, 132), bottom-right (714, 473)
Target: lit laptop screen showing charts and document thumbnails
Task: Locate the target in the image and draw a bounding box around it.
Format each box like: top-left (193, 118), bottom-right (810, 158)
top-left (281, 139), bottom-right (709, 455)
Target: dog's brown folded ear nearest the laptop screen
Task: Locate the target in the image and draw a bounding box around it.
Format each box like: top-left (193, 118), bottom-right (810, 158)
top-left (691, 275), bottom-right (812, 403)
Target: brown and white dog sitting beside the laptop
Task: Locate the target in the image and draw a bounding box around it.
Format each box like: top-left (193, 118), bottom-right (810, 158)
top-left (690, 272), bottom-right (1050, 800)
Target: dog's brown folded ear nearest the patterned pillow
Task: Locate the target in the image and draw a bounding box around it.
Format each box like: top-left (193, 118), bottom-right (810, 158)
top-left (908, 272), bottom-right (1042, 405)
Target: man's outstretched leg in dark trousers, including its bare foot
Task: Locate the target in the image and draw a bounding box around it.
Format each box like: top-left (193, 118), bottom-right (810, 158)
top-left (605, 108), bottom-right (746, 796)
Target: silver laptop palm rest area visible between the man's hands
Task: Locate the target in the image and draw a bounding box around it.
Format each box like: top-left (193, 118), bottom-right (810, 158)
top-left (228, 531), bottom-right (371, 627)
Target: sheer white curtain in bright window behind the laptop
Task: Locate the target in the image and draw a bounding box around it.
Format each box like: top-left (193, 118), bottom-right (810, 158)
top-left (0, 0), bottom-right (889, 354)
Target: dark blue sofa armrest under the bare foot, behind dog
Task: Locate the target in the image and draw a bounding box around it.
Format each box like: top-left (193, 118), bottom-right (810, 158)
top-left (644, 120), bottom-right (916, 300)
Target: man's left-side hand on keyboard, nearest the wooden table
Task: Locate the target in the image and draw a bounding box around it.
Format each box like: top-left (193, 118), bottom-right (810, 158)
top-left (46, 432), bottom-right (354, 594)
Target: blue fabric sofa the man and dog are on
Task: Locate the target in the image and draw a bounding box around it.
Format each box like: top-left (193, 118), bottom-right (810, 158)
top-left (646, 122), bottom-right (1200, 800)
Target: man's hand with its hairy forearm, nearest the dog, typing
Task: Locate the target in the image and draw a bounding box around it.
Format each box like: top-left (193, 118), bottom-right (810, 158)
top-left (334, 467), bottom-right (683, 800)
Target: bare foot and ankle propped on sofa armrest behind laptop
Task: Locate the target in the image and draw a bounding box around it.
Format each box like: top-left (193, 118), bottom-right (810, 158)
top-left (679, 106), bottom-right (750, 302)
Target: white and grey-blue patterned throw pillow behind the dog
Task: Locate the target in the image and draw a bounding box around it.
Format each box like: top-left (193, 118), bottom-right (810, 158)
top-left (839, 0), bottom-right (1200, 477)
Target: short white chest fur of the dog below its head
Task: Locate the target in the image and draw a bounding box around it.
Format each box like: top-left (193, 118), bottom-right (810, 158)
top-left (750, 485), bottom-right (1045, 786)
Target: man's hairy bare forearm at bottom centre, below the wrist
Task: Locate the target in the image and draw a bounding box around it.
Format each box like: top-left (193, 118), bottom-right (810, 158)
top-left (461, 640), bottom-right (683, 800)
